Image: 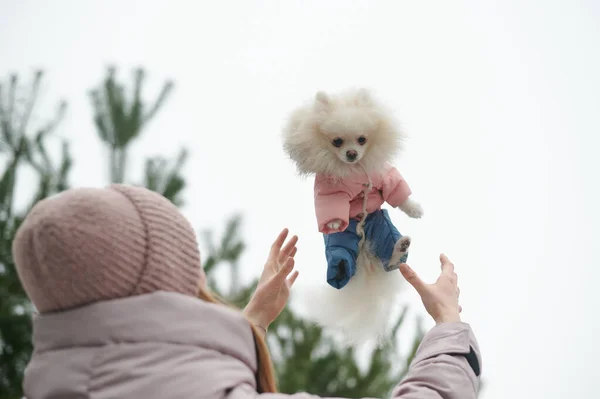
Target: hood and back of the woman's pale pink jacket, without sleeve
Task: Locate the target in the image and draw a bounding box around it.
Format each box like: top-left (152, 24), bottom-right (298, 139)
top-left (24, 291), bottom-right (257, 399)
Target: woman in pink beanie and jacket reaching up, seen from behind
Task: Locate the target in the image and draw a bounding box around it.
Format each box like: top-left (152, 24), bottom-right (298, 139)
top-left (13, 185), bottom-right (480, 399)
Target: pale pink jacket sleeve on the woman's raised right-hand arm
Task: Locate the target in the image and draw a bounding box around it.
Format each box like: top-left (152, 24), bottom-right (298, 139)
top-left (229, 323), bottom-right (481, 399)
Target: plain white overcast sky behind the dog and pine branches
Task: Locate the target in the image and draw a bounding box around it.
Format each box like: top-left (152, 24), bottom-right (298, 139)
top-left (0, 0), bottom-right (600, 399)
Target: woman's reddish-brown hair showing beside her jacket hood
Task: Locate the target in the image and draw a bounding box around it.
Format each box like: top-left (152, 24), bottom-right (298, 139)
top-left (198, 288), bottom-right (277, 393)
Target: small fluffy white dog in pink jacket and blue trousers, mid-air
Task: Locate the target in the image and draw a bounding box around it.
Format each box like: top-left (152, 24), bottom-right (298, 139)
top-left (283, 89), bottom-right (423, 340)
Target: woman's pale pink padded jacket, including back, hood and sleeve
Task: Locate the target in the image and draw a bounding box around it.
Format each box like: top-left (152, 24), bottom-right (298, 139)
top-left (24, 292), bottom-right (481, 399)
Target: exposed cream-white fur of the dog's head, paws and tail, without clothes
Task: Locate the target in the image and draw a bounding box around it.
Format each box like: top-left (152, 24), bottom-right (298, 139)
top-left (283, 89), bottom-right (423, 342)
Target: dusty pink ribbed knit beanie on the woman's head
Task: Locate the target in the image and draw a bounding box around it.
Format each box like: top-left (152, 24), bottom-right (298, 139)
top-left (12, 185), bottom-right (205, 313)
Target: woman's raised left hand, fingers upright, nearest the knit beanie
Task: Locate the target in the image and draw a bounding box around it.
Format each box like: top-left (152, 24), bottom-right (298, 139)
top-left (244, 229), bottom-right (298, 332)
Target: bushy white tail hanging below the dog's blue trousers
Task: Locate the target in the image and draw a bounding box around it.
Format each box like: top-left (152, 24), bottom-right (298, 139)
top-left (305, 242), bottom-right (403, 344)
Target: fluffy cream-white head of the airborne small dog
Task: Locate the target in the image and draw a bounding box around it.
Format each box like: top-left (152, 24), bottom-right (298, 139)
top-left (284, 90), bottom-right (402, 176)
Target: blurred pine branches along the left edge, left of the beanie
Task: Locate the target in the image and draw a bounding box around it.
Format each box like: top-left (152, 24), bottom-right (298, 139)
top-left (0, 71), bottom-right (72, 399)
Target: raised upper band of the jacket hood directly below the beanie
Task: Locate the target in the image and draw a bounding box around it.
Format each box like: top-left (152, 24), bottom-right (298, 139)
top-left (33, 291), bottom-right (256, 370)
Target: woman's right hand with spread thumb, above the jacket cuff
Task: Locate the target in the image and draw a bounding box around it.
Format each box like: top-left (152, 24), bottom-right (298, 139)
top-left (400, 254), bottom-right (462, 324)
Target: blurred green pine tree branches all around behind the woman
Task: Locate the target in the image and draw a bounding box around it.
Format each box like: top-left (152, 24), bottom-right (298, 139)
top-left (0, 68), bottom-right (423, 399)
